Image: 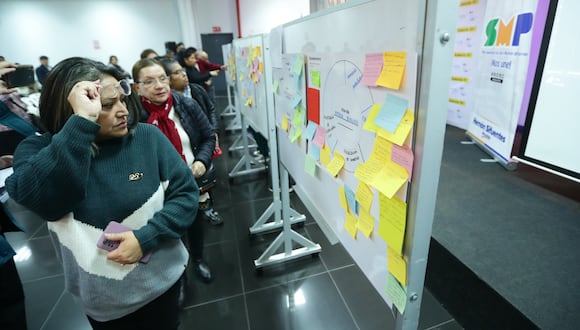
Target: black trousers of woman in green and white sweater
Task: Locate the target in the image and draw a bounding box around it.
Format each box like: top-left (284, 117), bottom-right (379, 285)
top-left (87, 277), bottom-right (183, 330)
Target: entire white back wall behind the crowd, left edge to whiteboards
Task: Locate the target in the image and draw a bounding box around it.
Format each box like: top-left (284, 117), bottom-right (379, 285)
top-left (0, 0), bottom-right (310, 71)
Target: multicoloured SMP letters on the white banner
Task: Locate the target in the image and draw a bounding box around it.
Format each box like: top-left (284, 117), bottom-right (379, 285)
top-left (484, 13), bottom-right (534, 47)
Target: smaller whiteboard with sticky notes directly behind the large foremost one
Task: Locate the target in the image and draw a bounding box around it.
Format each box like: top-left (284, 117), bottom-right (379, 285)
top-left (233, 34), bottom-right (271, 138)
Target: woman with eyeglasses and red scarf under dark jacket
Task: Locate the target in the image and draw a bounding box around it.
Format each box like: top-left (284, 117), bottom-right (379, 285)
top-left (132, 59), bottom-right (215, 282)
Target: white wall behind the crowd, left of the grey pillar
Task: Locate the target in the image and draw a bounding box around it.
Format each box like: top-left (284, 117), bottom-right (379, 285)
top-left (0, 0), bottom-right (182, 71)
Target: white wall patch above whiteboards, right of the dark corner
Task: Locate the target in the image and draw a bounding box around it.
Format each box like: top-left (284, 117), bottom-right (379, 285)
top-left (239, 0), bottom-right (310, 37)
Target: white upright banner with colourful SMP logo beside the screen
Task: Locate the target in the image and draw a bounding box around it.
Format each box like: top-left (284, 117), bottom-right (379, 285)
top-left (467, 0), bottom-right (538, 163)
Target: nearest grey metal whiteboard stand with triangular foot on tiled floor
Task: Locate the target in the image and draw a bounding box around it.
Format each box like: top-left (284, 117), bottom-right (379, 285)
top-left (254, 166), bottom-right (321, 269)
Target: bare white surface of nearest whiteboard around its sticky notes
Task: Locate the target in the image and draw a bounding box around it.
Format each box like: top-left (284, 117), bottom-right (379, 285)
top-left (276, 1), bottom-right (419, 306)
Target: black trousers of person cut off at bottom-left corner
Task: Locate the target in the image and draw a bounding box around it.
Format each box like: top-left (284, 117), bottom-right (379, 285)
top-left (0, 259), bottom-right (26, 330)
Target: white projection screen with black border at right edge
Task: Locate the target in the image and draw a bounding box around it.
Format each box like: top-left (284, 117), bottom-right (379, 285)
top-left (523, 0), bottom-right (580, 181)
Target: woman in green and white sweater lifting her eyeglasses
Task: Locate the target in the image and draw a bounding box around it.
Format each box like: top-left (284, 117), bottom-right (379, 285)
top-left (6, 58), bottom-right (199, 329)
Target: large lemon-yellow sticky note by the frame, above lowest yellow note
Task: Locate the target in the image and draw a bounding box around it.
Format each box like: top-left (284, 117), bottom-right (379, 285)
top-left (379, 194), bottom-right (407, 255)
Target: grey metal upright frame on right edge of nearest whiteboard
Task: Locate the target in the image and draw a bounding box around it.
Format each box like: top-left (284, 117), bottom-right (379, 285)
top-left (395, 0), bottom-right (459, 330)
